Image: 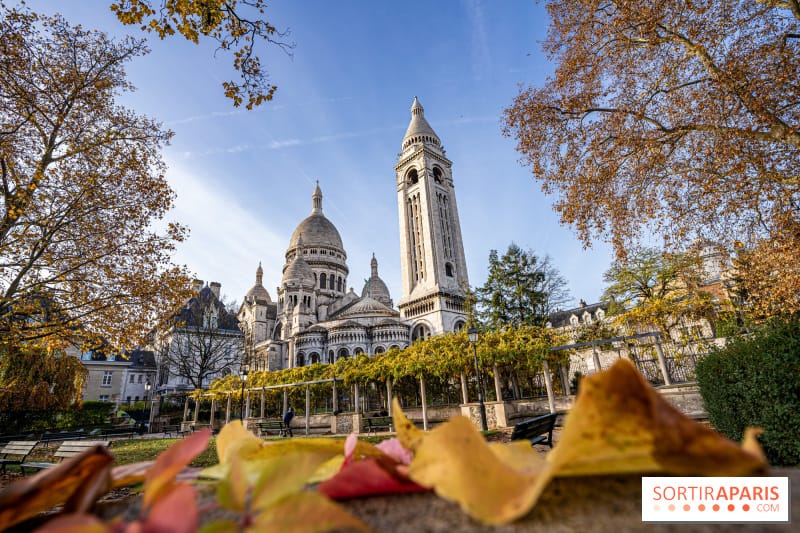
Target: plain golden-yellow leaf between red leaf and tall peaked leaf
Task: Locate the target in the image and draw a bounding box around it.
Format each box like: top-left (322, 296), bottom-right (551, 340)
top-left (406, 411), bottom-right (552, 524)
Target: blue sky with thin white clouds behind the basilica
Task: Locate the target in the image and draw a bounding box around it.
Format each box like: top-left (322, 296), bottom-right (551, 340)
top-left (27, 0), bottom-right (611, 308)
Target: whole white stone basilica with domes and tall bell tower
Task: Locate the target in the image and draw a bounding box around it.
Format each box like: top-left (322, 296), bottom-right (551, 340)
top-left (238, 101), bottom-right (468, 370)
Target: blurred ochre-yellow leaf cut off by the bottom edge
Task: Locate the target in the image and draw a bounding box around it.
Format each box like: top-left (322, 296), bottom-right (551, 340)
top-left (247, 492), bottom-right (369, 533)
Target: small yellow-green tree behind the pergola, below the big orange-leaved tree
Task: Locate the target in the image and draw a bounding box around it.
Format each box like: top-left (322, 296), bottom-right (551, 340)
top-left (603, 248), bottom-right (713, 335)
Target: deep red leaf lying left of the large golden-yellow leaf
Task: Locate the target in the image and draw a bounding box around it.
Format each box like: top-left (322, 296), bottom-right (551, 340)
top-left (317, 457), bottom-right (428, 500)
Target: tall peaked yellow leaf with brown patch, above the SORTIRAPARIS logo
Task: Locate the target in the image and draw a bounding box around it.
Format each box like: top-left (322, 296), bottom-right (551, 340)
top-left (547, 359), bottom-right (767, 476)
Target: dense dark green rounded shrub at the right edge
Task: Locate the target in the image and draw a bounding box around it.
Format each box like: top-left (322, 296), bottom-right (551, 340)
top-left (697, 317), bottom-right (800, 465)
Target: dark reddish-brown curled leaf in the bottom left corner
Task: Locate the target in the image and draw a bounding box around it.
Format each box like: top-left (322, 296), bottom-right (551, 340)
top-left (0, 446), bottom-right (114, 531)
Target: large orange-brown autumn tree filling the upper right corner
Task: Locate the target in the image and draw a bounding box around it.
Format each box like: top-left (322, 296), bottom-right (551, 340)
top-left (504, 0), bottom-right (800, 310)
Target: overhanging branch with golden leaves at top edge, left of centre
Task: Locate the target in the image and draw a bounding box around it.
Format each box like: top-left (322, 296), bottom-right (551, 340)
top-left (111, 0), bottom-right (294, 109)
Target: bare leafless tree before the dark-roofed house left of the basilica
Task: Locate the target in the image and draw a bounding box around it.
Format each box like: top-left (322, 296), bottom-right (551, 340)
top-left (156, 287), bottom-right (244, 389)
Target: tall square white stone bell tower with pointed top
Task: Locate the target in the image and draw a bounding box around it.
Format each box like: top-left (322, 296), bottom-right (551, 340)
top-left (394, 96), bottom-right (469, 340)
